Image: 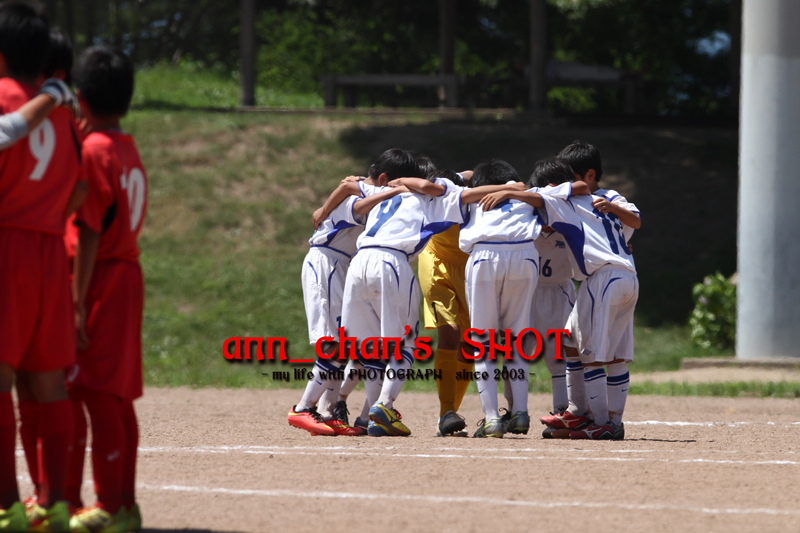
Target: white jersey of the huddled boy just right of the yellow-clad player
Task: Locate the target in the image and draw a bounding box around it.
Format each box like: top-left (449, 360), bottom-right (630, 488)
top-left (458, 183), bottom-right (572, 253)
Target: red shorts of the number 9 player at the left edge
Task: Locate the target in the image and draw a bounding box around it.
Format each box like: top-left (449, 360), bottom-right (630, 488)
top-left (0, 228), bottom-right (75, 372)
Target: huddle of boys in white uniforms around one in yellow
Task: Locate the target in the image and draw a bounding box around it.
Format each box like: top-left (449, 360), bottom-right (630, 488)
top-left (288, 137), bottom-right (641, 440)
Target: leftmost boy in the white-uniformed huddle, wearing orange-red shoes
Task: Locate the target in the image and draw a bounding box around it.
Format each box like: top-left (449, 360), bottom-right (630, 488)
top-left (287, 149), bottom-right (418, 435)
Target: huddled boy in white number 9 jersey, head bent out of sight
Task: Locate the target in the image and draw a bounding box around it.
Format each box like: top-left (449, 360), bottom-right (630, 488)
top-left (342, 172), bottom-right (520, 436)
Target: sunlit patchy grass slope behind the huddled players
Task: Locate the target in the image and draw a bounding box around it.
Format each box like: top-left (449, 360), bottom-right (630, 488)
top-left (123, 69), bottom-right (752, 395)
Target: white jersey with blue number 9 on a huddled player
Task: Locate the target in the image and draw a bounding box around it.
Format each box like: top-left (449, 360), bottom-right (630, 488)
top-left (358, 178), bottom-right (465, 261)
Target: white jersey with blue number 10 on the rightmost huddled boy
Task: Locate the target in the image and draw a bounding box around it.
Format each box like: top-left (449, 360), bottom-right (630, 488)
top-left (542, 189), bottom-right (639, 276)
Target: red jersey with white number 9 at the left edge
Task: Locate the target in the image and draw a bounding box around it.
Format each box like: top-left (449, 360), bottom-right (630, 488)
top-left (0, 78), bottom-right (81, 235)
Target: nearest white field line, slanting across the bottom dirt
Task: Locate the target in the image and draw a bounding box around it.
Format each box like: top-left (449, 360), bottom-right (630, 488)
top-left (137, 483), bottom-right (800, 516)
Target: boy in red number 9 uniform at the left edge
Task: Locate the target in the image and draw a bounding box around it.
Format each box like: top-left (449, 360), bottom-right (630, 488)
top-left (0, 3), bottom-right (80, 531)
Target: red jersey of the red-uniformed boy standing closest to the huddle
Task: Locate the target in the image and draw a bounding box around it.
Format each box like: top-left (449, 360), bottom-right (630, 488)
top-left (77, 130), bottom-right (147, 261)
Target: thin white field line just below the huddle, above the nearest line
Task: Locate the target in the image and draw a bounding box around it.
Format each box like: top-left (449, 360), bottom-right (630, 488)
top-left (126, 446), bottom-right (800, 466)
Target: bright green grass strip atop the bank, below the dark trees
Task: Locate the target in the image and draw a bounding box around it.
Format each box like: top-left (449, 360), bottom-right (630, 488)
top-left (131, 63), bottom-right (324, 109)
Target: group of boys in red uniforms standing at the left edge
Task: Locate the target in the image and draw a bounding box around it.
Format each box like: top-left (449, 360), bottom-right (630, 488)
top-left (0, 2), bottom-right (147, 533)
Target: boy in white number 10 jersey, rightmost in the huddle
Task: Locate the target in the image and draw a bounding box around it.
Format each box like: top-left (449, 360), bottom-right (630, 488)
top-left (484, 142), bottom-right (641, 440)
